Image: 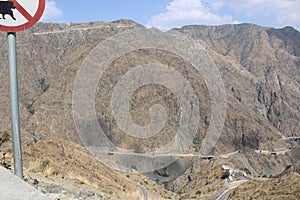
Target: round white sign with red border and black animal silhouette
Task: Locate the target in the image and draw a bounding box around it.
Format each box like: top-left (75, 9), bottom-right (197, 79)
top-left (0, 0), bottom-right (46, 32)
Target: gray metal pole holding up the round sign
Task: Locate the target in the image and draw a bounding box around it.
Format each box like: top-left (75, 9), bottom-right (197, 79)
top-left (7, 33), bottom-right (23, 179)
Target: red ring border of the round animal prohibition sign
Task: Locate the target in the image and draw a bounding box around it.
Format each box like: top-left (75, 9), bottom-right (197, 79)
top-left (0, 0), bottom-right (46, 32)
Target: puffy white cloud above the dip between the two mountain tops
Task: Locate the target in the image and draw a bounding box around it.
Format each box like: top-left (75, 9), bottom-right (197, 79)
top-left (147, 0), bottom-right (235, 29)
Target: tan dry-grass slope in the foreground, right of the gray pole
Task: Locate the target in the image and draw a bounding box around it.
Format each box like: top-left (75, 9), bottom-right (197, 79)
top-left (24, 140), bottom-right (169, 199)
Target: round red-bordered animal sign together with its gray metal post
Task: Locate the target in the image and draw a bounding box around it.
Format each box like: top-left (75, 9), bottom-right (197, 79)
top-left (0, 0), bottom-right (46, 178)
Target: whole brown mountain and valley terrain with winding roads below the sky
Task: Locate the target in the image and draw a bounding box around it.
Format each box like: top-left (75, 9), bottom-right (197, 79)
top-left (0, 20), bottom-right (300, 200)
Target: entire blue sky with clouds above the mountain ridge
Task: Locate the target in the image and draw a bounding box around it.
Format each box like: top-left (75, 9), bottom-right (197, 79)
top-left (42, 0), bottom-right (300, 30)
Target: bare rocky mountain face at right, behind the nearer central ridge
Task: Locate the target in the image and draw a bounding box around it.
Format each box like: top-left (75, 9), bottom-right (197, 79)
top-left (180, 24), bottom-right (300, 136)
